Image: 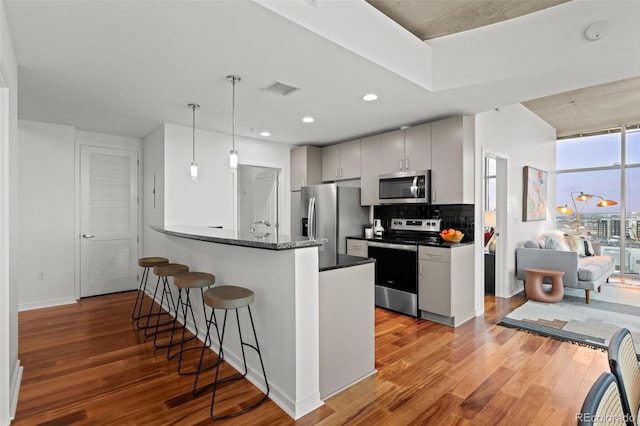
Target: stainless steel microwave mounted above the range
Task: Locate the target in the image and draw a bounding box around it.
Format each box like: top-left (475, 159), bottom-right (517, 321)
top-left (378, 170), bottom-right (431, 204)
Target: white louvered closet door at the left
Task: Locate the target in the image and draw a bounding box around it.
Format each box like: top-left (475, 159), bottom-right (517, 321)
top-left (80, 146), bottom-right (138, 297)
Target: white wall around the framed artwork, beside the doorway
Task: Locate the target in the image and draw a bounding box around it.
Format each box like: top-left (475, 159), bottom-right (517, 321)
top-left (476, 104), bottom-right (556, 297)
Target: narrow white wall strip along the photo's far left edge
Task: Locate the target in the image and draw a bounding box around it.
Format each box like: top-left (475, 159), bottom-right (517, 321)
top-left (0, 0), bottom-right (22, 425)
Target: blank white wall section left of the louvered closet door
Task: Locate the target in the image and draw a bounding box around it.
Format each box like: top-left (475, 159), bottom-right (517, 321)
top-left (14, 120), bottom-right (75, 309)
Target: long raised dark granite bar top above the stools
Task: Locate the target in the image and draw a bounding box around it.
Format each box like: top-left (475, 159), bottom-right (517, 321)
top-left (151, 225), bottom-right (327, 250)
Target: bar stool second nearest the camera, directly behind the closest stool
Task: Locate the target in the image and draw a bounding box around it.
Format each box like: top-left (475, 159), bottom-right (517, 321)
top-left (167, 272), bottom-right (216, 375)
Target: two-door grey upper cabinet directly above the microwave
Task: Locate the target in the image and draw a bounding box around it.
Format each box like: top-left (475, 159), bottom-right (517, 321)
top-left (381, 123), bottom-right (431, 174)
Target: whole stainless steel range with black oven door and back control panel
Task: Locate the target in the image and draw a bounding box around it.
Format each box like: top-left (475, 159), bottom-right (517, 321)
top-left (368, 219), bottom-right (441, 317)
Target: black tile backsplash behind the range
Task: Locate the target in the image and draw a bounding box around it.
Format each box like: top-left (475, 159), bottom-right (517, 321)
top-left (373, 204), bottom-right (474, 241)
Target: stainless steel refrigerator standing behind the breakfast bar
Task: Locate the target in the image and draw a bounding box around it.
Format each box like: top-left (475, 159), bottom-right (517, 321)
top-left (300, 183), bottom-right (369, 254)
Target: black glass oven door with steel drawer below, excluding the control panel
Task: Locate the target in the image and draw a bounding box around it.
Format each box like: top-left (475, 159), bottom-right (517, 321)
top-left (368, 241), bottom-right (418, 316)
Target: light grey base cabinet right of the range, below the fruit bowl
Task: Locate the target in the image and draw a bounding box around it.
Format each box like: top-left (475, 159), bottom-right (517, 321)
top-left (418, 244), bottom-right (474, 327)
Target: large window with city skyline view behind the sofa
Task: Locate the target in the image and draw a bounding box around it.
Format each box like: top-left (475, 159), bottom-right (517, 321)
top-left (556, 129), bottom-right (640, 275)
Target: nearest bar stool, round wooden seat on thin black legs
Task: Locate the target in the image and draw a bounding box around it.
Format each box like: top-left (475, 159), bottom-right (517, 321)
top-left (200, 285), bottom-right (269, 420)
